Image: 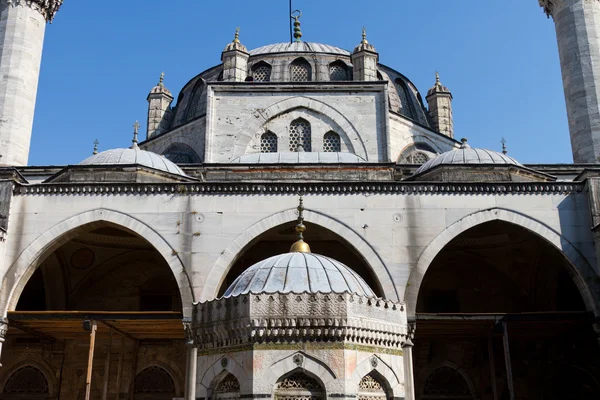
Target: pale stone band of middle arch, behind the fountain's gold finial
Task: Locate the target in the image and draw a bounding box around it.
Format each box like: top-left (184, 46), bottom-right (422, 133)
top-left (200, 208), bottom-right (400, 301)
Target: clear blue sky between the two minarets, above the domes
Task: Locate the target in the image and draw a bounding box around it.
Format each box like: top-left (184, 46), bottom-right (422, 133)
top-left (29, 0), bottom-right (572, 165)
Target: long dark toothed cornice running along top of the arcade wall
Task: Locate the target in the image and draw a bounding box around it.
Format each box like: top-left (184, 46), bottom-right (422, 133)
top-left (14, 181), bottom-right (585, 195)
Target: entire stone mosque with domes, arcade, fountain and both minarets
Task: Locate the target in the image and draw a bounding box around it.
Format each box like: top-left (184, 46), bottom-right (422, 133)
top-left (0, 0), bottom-right (600, 400)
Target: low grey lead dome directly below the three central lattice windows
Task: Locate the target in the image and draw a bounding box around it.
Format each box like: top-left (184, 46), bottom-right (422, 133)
top-left (231, 151), bottom-right (365, 164)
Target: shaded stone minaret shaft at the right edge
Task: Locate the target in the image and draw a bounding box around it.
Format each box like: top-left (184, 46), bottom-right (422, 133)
top-left (539, 0), bottom-right (600, 163)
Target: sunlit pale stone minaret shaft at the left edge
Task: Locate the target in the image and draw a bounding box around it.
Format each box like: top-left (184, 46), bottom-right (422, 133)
top-left (0, 0), bottom-right (63, 165)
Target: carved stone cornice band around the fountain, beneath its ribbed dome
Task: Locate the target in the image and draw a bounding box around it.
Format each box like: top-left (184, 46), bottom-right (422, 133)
top-left (194, 292), bottom-right (407, 349)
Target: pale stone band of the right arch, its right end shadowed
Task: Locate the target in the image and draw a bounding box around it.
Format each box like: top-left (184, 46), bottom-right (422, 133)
top-left (404, 208), bottom-right (599, 317)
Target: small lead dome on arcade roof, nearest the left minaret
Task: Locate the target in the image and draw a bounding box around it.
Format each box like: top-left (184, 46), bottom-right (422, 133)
top-left (79, 146), bottom-right (185, 176)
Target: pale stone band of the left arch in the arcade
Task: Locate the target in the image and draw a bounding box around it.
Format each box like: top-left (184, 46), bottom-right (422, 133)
top-left (0, 208), bottom-right (194, 317)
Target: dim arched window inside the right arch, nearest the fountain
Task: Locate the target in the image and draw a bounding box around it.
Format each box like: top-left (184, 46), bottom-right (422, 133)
top-left (422, 367), bottom-right (473, 400)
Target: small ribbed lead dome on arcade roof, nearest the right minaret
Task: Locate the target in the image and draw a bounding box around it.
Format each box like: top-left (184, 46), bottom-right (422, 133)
top-left (415, 139), bottom-right (522, 175)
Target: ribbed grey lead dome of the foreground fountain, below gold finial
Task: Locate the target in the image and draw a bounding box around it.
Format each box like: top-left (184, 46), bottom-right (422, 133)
top-left (224, 253), bottom-right (375, 297)
